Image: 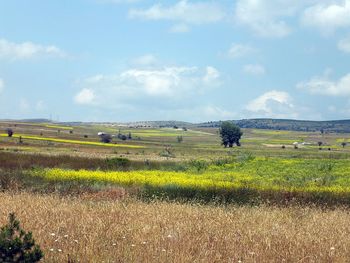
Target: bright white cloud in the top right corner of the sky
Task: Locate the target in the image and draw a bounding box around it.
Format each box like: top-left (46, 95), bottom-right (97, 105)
top-left (302, 0), bottom-right (350, 34)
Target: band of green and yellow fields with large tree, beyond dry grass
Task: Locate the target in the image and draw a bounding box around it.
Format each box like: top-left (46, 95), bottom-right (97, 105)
top-left (0, 122), bottom-right (350, 205)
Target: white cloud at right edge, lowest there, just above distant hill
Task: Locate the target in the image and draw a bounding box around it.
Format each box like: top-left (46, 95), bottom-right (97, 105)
top-left (297, 73), bottom-right (350, 96)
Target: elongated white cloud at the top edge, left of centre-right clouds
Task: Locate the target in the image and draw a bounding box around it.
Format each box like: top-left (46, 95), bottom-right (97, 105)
top-left (129, 0), bottom-right (225, 25)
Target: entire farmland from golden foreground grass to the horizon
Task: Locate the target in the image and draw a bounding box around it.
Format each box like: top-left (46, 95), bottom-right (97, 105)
top-left (0, 122), bottom-right (350, 262)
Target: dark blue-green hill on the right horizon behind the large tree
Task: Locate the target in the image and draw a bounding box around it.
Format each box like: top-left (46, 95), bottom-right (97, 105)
top-left (196, 119), bottom-right (350, 133)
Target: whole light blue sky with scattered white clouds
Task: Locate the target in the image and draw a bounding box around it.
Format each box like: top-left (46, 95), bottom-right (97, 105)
top-left (0, 0), bottom-right (350, 122)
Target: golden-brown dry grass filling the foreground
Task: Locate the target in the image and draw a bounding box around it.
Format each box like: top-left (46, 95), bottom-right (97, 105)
top-left (0, 193), bottom-right (350, 262)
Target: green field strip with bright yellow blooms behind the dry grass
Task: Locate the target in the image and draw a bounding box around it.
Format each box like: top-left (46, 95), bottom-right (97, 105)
top-left (16, 157), bottom-right (350, 204)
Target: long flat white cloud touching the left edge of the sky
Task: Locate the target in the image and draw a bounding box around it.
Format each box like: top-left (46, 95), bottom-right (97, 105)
top-left (0, 39), bottom-right (66, 60)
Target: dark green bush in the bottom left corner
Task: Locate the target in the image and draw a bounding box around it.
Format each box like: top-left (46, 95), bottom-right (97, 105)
top-left (0, 213), bottom-right (43, 263)
